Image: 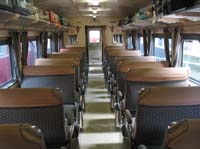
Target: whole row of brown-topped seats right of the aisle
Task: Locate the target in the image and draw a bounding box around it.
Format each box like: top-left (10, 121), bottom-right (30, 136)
top-left (104, 48), bottom-right (200, 148)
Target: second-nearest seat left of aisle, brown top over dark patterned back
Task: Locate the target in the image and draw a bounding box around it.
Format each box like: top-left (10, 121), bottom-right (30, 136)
top-left (0, 88), bottom-right (78, 148)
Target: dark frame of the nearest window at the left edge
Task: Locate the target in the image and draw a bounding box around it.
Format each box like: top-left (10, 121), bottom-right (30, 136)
top-left (0, 39), bottom-right (17, 89)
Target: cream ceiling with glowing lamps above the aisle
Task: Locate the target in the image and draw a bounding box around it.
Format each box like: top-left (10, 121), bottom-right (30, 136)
top-left (34, 0), bottom-right (151, 17)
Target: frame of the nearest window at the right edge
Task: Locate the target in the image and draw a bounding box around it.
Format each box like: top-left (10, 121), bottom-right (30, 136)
top-left (180, 33), bottom-right (200, 85)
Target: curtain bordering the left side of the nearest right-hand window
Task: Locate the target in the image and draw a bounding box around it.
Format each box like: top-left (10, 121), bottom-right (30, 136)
top-left (171, 28), bottom-right (182, 67)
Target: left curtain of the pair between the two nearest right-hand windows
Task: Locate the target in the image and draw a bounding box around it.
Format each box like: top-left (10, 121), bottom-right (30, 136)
top-left (164, 28), bottom-right (171, 67)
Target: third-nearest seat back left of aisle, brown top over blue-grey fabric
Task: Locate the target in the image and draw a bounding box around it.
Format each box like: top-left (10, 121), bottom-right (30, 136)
top-left (21, 65), bottom-right (76, 104)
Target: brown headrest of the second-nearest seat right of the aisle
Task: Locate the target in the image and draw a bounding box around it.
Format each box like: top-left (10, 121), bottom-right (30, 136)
top-left (139, 87), bottom-right (200, 106)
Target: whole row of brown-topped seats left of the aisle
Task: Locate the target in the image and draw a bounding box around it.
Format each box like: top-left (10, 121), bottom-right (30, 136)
top-left (0, 48), bottom-right (88, 148)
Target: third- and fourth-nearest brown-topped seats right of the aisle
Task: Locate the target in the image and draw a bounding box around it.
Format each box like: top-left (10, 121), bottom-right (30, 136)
top-left (115, 62), bottom-right (189, 126)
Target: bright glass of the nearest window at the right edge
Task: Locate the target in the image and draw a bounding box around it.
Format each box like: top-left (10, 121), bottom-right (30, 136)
top-left (182, 39), bottom-right (200, 83)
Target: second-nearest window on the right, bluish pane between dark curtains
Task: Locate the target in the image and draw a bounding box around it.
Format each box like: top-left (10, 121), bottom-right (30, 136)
top-left (153, 37), bottom-right (171, 61)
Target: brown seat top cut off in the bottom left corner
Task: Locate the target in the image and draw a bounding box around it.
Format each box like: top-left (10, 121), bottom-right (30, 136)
top-left (0, 124), bottom-right (46, 149)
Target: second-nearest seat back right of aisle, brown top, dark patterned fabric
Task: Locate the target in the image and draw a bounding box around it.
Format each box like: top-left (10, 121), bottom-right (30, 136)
top-left (134, 87), bottom-right (200, 146)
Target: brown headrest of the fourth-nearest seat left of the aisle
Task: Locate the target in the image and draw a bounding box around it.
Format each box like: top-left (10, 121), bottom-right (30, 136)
top-left (35, 58), bottom-right (80, 66)
